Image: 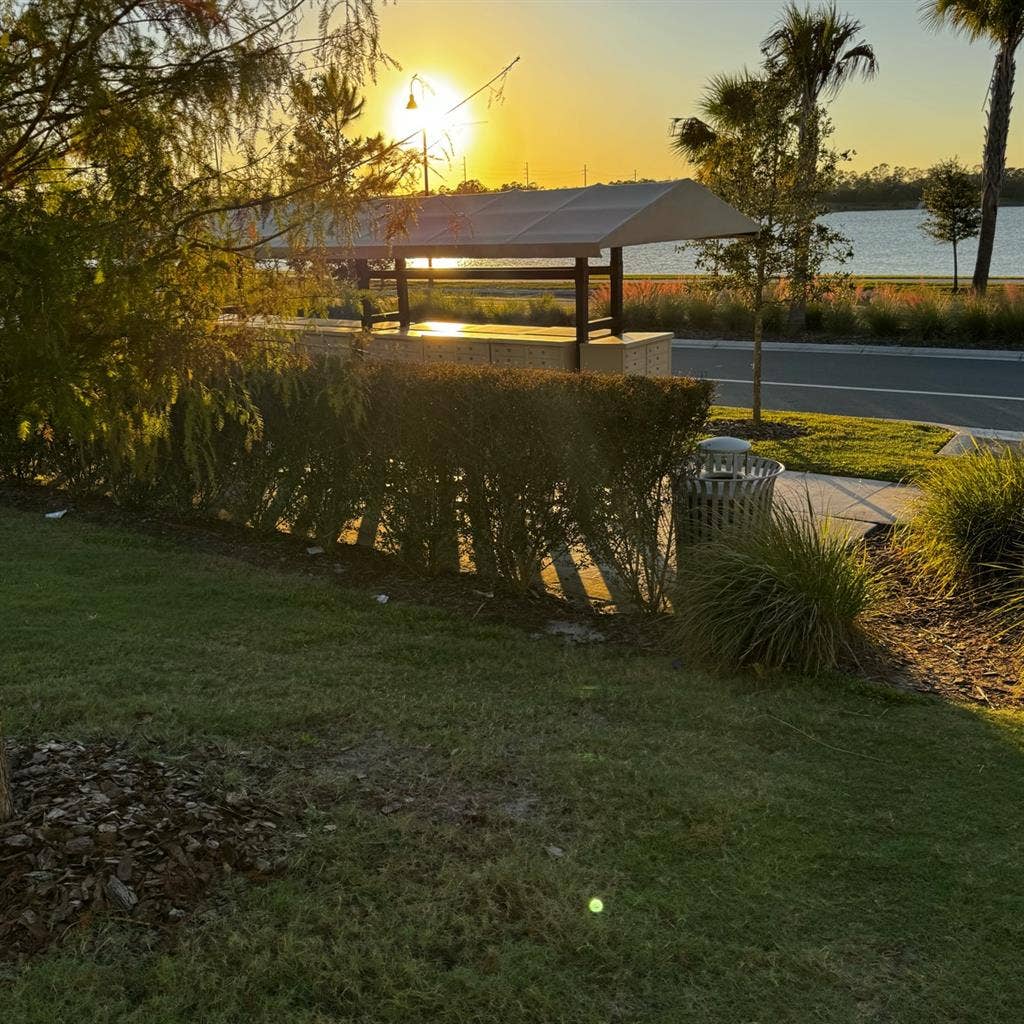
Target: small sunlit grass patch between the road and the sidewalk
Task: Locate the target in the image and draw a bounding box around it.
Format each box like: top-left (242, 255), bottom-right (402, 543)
top-left (712, 406), bottom-right (953, 480)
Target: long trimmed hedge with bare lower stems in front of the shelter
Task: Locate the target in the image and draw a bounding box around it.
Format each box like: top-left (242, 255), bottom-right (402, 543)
top-left (4, 358), bottom-right (712, 608)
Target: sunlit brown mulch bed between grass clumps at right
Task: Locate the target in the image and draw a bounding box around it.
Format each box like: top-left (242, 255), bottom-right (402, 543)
top-left (857, 530), bottom-right (1024, 708)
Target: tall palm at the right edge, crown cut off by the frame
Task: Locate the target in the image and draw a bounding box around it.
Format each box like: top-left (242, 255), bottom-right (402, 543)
top-left (922, 0), bottom-right (1024, 293)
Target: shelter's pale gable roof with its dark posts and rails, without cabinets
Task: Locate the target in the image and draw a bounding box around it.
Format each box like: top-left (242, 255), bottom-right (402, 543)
top-left (251, 179), bottom-right (760, 376)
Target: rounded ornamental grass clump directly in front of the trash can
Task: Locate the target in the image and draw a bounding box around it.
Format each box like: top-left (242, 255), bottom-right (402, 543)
top-left (673, 507), bottom-right (885, 675)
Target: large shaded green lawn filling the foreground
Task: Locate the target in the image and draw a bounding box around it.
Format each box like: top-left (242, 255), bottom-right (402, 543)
top-left (6, 509), bottom-right (1024, 1024)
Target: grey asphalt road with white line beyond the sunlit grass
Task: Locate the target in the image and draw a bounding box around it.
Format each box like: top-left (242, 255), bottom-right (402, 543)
top-left (672, 341), bottom-right (1024, 430)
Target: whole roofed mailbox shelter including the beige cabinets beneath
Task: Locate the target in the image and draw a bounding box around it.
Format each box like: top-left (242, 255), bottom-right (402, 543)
top-left (253, 179), bottom-right (760, 376)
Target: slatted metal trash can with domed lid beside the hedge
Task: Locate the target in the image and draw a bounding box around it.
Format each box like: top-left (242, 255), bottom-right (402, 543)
top-left (676, 437), bottom-right (785, 545)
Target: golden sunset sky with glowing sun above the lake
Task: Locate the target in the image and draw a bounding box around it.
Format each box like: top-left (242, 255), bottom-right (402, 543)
top-left (364, 0), bottom-right (1024, 187)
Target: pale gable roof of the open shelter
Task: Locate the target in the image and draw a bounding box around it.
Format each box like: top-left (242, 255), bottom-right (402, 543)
top-left (264, 179), bottom-right (760, 259)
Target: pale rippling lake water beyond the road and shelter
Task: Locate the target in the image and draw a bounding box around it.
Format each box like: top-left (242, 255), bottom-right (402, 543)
top-left (415, 206), bottom-right (1024, 280)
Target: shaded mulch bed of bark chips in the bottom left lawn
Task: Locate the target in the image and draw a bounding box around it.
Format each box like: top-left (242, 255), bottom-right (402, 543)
top-left (0, 740), bottom-right (284, 959)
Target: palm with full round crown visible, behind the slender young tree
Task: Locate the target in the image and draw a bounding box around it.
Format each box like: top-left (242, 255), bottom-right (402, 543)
top-left (762, 0), bottom-right (879, 326)
